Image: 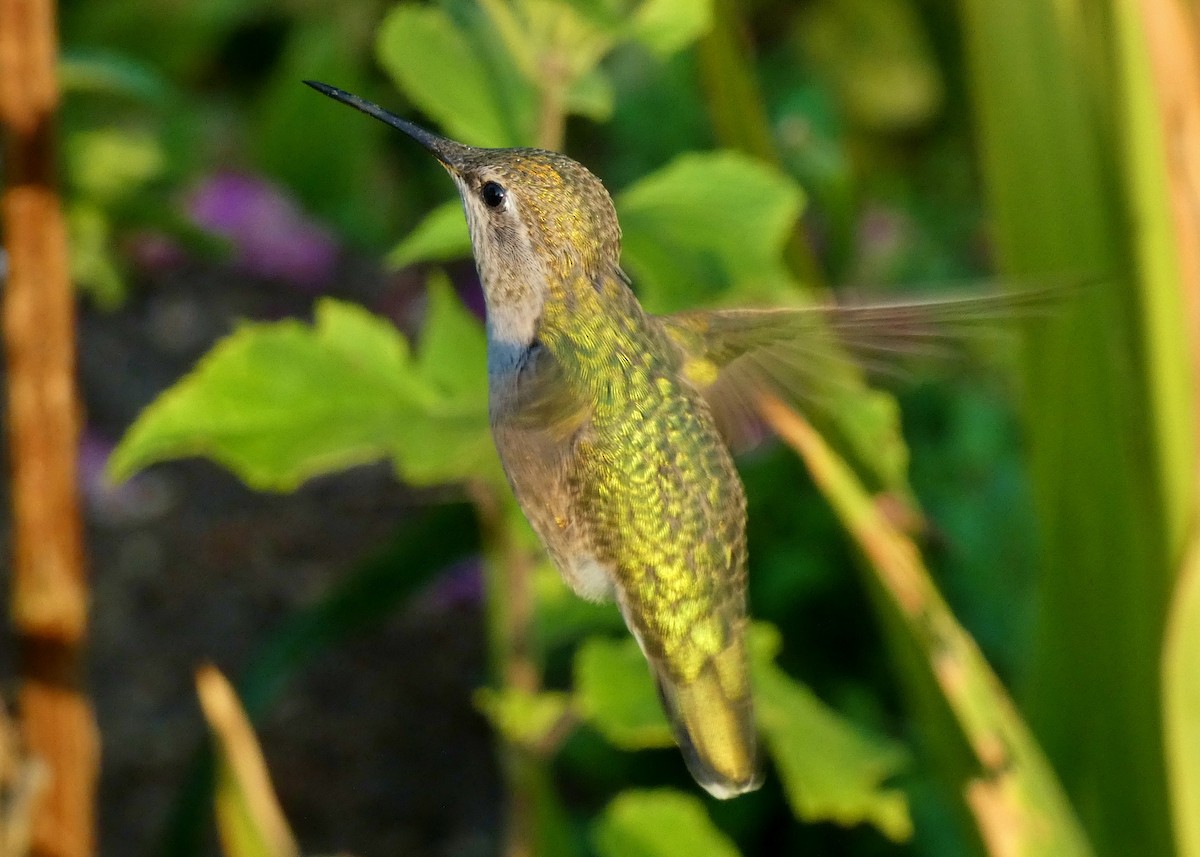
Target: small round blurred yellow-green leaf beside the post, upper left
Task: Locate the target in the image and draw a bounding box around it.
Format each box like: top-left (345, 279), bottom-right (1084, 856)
top-left (67, 127), bottom-right (166, 203)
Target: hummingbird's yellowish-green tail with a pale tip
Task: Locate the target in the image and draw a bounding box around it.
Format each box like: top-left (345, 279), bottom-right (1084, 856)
top-left (652, 635), bottom-right (762, 798)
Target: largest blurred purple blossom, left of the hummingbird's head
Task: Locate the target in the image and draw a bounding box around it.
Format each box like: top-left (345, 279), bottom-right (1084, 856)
top-left (187, 173), bottom-right (337, 290)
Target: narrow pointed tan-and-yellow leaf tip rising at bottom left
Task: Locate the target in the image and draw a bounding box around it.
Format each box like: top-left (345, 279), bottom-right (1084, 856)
top-left (196, 666), bottom-right (300, 857)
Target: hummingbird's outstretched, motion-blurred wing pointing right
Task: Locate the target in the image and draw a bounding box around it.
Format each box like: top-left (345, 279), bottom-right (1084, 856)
top-left (661, 289), bottom-right (1063, 449)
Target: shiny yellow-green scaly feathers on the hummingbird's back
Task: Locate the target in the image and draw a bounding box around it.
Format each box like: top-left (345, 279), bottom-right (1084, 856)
top-left (540, 272), bottom-right (746, 682)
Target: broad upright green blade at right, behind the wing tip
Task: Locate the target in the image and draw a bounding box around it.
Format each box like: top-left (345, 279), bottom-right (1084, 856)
top-left (960, 0), bottom-right (1195, 855)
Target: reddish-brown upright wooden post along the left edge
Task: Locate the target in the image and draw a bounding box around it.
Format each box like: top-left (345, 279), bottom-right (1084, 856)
top-left (0, 0), bottom-right (98, 857)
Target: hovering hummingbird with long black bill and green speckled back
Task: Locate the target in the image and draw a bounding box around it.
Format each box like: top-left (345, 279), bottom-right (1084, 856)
top-left (306, 82), bottom-right (1036, 798)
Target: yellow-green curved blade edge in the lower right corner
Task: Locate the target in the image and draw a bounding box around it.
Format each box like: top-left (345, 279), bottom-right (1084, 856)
top-left (1163, 534), bottom-right (1200, 857)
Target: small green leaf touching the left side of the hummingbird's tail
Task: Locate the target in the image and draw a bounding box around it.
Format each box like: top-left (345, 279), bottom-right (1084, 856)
top-left (575, 636), bottom-right (674, 750)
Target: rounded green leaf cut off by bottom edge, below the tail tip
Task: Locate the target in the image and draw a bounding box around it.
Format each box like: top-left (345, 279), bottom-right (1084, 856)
top-left (592, 789), bottom-right (739, 857)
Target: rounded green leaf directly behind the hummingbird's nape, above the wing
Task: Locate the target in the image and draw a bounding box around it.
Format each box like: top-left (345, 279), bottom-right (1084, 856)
top-left (616, 151), bottom-right (803, 312)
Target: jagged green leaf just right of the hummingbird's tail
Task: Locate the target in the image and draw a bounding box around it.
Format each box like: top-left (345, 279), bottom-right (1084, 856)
top-left (750, 623), bottom-right (912, 841)
